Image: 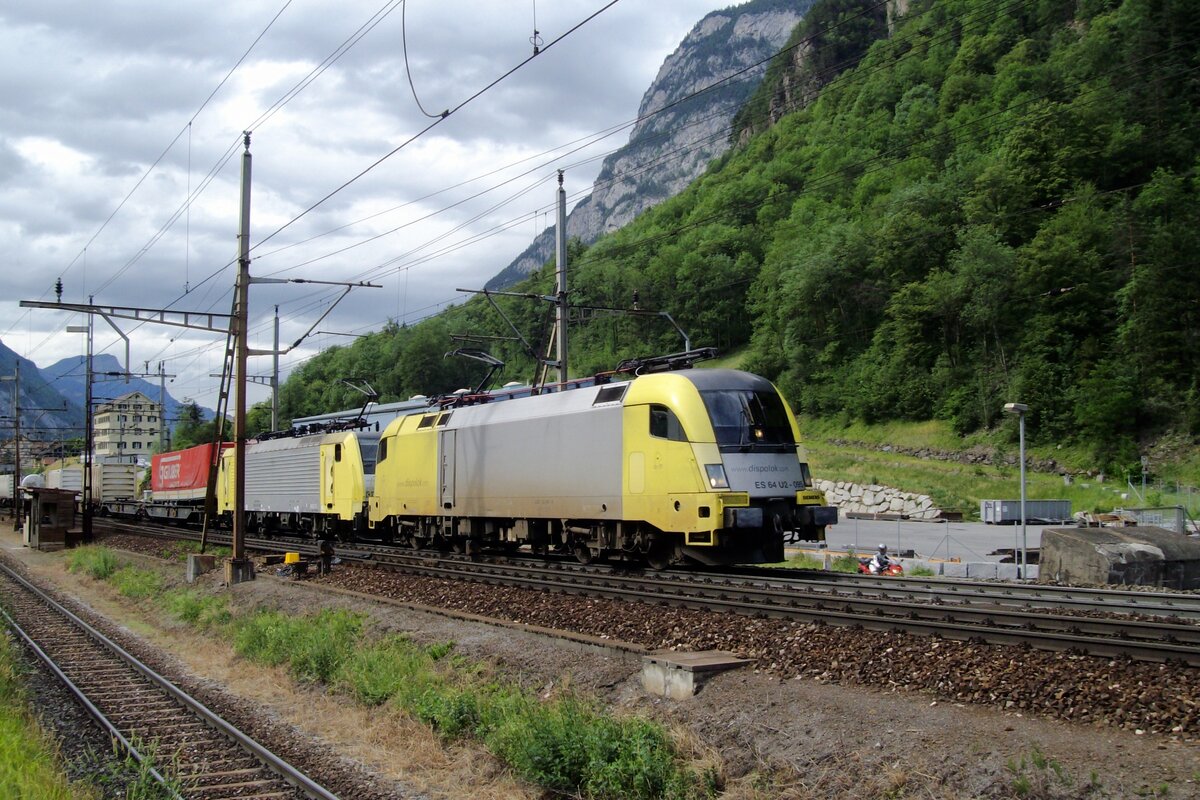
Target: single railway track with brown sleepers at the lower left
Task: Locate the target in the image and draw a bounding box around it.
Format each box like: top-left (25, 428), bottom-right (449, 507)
top-left (0, 556), bottom-right (336, 800)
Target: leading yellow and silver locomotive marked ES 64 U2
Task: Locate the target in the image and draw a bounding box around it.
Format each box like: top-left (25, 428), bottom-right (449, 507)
top-left (367, 369), bottom-right (838, 567)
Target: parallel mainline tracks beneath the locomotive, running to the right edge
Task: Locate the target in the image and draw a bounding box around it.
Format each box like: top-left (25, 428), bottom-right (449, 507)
top-left (98, 522), bottom-right (1200, 667)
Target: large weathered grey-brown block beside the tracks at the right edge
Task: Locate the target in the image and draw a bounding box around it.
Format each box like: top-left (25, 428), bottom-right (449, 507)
top-left (1038, 527), bottom-right (1200, 589)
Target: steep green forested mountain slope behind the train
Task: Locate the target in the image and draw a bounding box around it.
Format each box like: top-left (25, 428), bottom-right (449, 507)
top-left (278, 0), bottom-right (1200, 474)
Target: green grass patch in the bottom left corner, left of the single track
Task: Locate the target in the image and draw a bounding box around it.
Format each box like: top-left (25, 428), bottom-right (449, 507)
top-left (0, 636), bottom-right (96, 800)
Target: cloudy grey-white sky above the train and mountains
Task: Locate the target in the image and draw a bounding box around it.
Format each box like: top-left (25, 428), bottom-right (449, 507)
top-left (0, 0), bottom-right (730, 405)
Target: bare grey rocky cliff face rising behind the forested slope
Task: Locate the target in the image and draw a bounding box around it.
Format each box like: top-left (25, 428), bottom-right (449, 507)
top-left (487, 0), bottom-right (812, 289)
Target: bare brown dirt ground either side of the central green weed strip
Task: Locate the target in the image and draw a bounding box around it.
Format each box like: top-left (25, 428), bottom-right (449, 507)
top-left (0, 531), bottom-right (1200, 800)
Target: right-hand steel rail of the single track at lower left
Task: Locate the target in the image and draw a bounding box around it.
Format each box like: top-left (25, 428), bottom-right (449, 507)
top-left (0, 564), bottom-right (337, 800)
